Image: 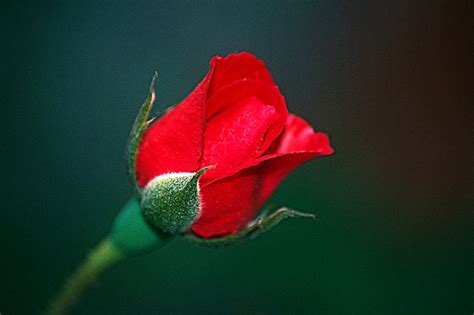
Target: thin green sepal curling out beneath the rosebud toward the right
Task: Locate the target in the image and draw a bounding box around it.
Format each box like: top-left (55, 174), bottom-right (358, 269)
top-left (185, 207), bottom-right (316, 248)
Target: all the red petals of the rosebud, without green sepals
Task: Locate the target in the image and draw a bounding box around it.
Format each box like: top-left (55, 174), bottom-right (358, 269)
top-left (131, 52), bottom-right (333, 238)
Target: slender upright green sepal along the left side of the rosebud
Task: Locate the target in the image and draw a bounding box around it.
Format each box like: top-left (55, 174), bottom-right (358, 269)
top-left (126, 71), bottom-right (158, 194)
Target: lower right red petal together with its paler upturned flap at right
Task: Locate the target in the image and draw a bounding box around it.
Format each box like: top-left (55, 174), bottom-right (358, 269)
top-left (192, 115), bottom-right (333, 238)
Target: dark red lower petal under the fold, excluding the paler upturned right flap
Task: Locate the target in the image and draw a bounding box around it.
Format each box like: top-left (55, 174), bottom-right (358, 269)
top-left (191, 152), bottom-right (330, 238)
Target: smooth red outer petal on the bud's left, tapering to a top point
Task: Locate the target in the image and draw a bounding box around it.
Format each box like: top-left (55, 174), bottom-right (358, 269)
top-left (136, 61), bottom-right (214, 187)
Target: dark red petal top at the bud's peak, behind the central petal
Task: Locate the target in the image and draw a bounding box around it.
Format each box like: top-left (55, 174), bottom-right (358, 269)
top-left (209, 52), bottom-right (274, 97)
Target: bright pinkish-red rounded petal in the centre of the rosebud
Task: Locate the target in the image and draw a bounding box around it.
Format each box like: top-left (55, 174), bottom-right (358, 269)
top-left (201, 79), bottom-right (288, 179)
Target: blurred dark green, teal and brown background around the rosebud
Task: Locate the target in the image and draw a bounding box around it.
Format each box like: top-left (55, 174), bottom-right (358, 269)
top-left (0, 0), bottom-right (474, 315)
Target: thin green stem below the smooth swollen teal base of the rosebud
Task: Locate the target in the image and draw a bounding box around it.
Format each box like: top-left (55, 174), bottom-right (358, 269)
top-left (46, 239), bottom-right (125, 315)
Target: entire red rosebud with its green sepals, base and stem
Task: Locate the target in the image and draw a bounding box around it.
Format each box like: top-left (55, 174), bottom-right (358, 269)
top-left (47, 53), bottom-right (333, 314)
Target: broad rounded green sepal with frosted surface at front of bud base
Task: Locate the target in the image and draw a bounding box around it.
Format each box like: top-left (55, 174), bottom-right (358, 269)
top-left (141, 168), bottom-right (207, 234)
